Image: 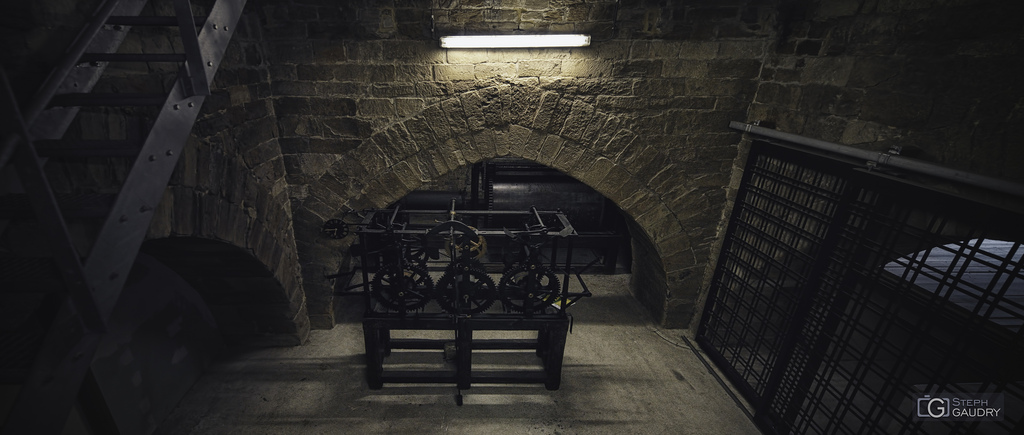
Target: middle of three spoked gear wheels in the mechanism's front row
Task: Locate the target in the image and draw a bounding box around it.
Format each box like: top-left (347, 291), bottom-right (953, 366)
top-left (437, 265), bottom-right (498, 314)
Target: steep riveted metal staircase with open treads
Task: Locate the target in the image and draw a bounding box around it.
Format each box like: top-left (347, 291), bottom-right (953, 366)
top-left (0, 0), bottom-right (246, 434)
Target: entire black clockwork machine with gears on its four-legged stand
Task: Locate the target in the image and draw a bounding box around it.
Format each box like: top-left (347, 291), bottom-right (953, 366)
top-left (346, 201), bottom-right (591, 395)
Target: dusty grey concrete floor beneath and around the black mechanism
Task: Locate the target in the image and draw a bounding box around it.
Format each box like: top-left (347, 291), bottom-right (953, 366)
top-left (151, 274), bottom-right (759, 435)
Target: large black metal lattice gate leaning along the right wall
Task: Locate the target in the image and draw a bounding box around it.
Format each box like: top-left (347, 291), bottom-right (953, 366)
top-left (697, 141), bottom-right (1024, 434)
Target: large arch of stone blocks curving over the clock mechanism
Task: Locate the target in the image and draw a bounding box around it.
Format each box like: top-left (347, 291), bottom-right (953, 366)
top-left (296, 84), bottom-right (702, 328)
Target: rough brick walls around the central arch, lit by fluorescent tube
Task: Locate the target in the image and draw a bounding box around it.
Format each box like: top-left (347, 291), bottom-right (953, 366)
top-left (8, 0), bottom-right (1024, 330)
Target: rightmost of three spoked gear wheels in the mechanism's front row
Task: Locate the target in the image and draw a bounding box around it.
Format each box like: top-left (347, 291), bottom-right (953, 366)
top-left (499, 266), bottom-right (561, 312)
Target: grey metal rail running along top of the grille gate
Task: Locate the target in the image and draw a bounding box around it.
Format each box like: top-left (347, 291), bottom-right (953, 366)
top-left (729, 121), bottom-right (1024, 198)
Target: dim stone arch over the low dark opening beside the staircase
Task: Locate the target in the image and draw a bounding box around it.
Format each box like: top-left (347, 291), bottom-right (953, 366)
top-left (147, 185), bottom-right (309, 346)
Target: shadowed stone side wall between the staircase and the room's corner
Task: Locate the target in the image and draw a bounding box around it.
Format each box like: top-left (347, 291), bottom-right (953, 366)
top-left (136, 5), bottom-right (309, 345)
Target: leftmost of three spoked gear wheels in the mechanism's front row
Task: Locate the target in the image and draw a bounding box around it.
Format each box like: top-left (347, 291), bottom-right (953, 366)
top-left (370, 264), bottom-right (434, 311)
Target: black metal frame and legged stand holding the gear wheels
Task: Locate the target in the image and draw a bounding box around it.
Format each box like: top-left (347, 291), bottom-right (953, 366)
top-left (355, 205), bottom-right (591, 397)
